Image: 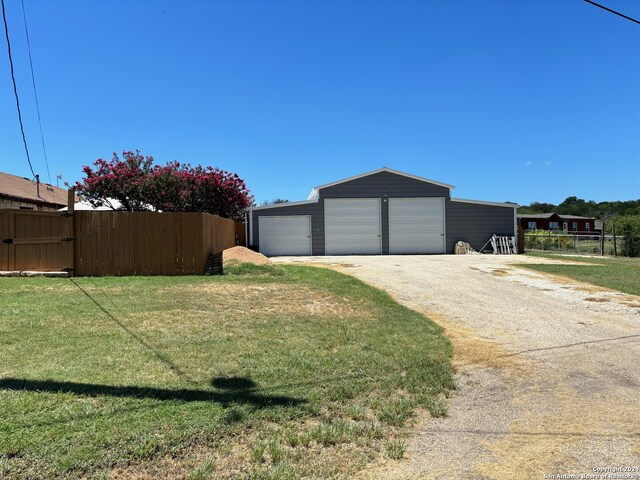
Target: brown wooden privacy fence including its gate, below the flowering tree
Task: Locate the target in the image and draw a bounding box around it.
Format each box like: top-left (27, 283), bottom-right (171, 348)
top-left (0, 210), bottom-right (236, 276)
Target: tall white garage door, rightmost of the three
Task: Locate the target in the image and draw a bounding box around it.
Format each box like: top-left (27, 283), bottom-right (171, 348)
top-left (389, 198), bottom-right (444, 255)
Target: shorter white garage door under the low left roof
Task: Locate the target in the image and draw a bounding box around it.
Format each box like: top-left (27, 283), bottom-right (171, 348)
top-left (258, 215), bottom-right (311, 256)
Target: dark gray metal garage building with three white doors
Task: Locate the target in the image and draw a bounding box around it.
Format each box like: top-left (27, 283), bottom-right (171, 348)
top-left (248, 168), bottom-right (517, 256)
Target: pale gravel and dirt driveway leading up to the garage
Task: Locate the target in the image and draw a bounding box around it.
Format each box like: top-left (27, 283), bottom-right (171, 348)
top-left (276, 255), bottom-right (640, 479)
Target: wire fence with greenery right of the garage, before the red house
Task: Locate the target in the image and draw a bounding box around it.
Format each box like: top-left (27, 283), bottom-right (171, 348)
top-left (524, 230), bottom-right (624, 255)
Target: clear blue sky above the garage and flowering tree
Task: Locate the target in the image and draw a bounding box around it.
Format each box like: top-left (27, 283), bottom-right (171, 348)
top-left (0, 0), bottom-right (640, 204)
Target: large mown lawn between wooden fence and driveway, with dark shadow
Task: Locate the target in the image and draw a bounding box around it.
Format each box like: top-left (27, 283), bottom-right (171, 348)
top-left (0, 265), bottom-right (453, 479)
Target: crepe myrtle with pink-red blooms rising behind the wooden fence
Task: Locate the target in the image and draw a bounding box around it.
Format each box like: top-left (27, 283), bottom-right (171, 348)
top-left (75, 151), bottom-right (253, 220)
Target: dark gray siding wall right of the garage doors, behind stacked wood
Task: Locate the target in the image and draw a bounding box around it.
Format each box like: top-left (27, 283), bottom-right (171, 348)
top-left (445, 201), bottom-right (515, 253)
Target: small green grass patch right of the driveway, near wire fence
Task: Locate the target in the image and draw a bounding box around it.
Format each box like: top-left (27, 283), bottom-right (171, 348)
top-left (522, 253), bottom-right (640, 295)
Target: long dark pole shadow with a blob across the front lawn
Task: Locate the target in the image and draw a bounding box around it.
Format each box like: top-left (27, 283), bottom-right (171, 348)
top-left (0, 377), bottom-right (306, 408)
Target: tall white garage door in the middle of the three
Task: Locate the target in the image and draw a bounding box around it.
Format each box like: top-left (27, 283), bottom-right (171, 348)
top-left (324, 198), bottom-right (382, 255)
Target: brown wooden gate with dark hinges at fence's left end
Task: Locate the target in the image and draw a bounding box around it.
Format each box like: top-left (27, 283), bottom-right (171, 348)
top-left (0, 210), bottom-right (73, 271)
